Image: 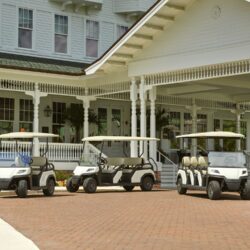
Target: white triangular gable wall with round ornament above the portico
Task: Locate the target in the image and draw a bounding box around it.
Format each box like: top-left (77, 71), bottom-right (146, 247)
top-left (129, 0), bottom-right (250, 76)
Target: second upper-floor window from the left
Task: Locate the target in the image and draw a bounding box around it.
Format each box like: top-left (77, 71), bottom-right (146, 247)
top-left (55, 15), bottom-right (68, 53)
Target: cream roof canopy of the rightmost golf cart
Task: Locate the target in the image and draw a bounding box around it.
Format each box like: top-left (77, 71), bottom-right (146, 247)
top-left (176, 131), bottom-right (245, 139)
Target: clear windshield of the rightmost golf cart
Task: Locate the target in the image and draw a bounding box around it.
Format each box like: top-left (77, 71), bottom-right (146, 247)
top-left (208, 152), bottom-right (246, 168)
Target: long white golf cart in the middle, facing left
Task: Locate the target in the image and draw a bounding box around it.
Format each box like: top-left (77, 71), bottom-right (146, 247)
top-left (66, 136), bottom-right (158, 193)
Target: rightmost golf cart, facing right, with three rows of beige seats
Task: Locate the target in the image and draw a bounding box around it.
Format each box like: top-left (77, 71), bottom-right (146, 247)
top-left (176, 131), bottom-right (250, 200)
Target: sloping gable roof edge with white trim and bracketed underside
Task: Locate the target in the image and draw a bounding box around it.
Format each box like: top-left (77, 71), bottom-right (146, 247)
top-left (84, 0), bottom-right (194, 75)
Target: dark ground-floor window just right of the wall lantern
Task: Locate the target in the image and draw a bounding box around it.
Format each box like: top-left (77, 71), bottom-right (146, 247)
top-left (52, 102), bottom-right (66, 142)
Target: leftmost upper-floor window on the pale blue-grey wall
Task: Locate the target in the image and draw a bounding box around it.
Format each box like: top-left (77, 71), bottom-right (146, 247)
top-left (18, 8), bottom-right (33, 49)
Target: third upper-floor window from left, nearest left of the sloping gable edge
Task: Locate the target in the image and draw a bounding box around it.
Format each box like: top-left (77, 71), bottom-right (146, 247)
top-left (86, 20), bottom-right (99, 57)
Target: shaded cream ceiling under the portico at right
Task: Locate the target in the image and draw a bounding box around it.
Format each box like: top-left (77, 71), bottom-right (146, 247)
top-left (158, 74), bottom-right (250, 103)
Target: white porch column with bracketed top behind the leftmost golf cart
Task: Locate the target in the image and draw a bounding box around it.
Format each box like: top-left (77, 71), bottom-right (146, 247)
top-left (25, 83), bottom-right (48, 156)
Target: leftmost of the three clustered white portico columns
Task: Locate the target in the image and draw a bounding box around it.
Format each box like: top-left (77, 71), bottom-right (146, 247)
top-left (130, 78), bottom-right (138, 157)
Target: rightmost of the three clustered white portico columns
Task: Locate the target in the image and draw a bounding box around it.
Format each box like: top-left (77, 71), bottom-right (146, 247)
top-left (149, 87), bottom-right (157, 161)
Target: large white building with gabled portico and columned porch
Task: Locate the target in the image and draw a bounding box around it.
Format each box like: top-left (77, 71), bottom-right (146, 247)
top-left (0, 0), bottom-right (250, 188)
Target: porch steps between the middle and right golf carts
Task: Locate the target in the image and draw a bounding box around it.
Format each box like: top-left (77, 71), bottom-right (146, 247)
top-left (161, 164), bottom-right (177, 189)
